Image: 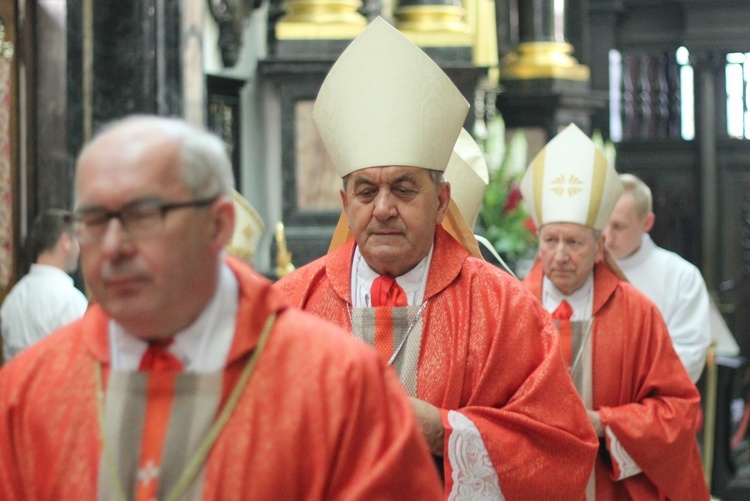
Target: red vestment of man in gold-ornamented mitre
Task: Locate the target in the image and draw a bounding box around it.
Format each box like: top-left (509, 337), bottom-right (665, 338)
top-left (524, 262), bottom-right (710, 501)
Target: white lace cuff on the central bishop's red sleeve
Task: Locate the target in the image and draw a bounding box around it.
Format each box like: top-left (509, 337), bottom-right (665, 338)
top-left (448, 411), bottom-right (505, 501)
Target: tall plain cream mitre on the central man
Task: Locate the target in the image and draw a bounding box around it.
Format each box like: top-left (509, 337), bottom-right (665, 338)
top-left (313, 17), bottom-right (469, 177)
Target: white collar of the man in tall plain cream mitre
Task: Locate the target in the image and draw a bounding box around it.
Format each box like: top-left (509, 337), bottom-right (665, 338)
top-left (351, 245), bottom-right (435, 308)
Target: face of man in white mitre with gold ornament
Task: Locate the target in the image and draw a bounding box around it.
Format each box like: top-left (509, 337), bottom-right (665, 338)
top-left (538, 223), bottom-right (604, 294)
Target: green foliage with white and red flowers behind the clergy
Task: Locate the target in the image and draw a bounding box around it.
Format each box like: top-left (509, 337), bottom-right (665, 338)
top-left (478, 115), bottom-right (536, 263)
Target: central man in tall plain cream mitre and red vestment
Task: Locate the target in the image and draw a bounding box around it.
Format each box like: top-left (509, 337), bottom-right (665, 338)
top-left (276, 18), bottom-right (597, 500)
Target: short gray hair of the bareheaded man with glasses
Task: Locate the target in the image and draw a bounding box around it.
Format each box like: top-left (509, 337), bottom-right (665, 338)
top-left (76, 115), bottom-right (234, 198)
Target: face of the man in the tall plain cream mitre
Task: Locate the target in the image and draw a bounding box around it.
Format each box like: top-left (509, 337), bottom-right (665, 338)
top-left (341, 166), bottom-right (450, 277)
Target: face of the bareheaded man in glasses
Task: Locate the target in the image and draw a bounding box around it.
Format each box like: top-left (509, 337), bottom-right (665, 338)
top-left (76, 127), bottom-right (234, 339)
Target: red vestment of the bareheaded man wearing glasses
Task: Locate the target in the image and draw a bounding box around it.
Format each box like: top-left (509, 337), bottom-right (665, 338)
top-left (0, 260), bottom-right (441, 500)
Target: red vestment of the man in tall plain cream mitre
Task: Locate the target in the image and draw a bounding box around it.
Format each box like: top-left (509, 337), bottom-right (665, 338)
top-left (275, 227), bottom-right (597, 500)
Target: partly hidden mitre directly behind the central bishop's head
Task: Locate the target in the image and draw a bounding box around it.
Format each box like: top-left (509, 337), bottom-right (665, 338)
top-left (444, 129), bottom-right (490, 228)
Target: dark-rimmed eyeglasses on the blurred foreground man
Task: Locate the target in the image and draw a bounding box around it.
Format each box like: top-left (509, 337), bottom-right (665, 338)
top-left (71, 195), bottom-right (219, 243)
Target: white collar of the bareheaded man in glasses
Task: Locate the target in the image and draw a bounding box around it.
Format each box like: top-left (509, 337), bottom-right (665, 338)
top-left (109, 263), bottom-right (239, 373)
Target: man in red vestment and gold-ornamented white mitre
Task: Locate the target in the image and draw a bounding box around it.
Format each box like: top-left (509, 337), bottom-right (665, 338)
top-left (521, 125), bottom-right (709, 501)
